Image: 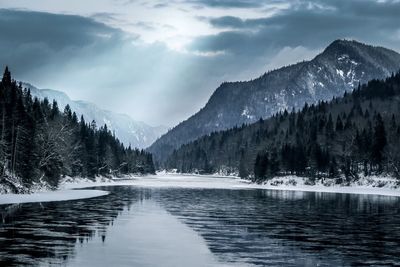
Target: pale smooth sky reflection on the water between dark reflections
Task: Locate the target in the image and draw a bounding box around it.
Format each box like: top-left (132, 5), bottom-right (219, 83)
top-left (68, 200), bottom-right (220, 267)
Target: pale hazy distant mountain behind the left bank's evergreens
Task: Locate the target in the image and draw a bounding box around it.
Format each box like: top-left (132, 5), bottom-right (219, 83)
top-left (23, 83), bottom-right (167, 149)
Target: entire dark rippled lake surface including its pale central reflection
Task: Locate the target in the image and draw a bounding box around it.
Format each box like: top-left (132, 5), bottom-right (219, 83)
top-left (0, 181), bottom-right (400, 266)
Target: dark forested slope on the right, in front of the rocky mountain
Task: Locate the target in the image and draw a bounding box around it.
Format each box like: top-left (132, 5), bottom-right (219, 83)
top-left (167, 73), bottom-right (400, 181)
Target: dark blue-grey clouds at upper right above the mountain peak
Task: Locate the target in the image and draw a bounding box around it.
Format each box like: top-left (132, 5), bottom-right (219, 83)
top-left (191, 0), bottom-right (400, 56)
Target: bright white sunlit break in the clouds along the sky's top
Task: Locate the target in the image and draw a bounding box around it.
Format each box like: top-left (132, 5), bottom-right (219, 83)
top-left (0, 0), bottom-right (290, 52)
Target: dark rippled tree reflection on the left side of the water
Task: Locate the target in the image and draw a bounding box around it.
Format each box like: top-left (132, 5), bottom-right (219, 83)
top-left (0, 187), bottom-right (150, 266)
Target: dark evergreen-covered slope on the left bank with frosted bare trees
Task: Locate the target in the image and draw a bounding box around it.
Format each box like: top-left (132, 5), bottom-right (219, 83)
top-left (0, 67), bottom-right (154, 192)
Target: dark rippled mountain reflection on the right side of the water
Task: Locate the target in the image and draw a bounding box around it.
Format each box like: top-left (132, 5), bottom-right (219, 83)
top-left (159, 190), bottom-right (400, 266)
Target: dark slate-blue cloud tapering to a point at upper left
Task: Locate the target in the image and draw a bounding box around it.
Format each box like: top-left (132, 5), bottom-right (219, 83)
top-left (0, 9), bottom-right (125, 75)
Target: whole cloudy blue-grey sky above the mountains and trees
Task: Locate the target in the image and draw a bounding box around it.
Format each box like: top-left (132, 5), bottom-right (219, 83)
top-left (0, 0), bottom-right (400, 126)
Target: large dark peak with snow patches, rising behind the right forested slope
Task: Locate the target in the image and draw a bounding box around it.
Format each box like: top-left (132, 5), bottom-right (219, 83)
top-left (149, 40), bottom-right (400, 164)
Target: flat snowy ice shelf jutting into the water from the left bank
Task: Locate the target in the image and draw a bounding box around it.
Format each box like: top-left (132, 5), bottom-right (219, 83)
top-left (0, 189), bottom-right (109, 205)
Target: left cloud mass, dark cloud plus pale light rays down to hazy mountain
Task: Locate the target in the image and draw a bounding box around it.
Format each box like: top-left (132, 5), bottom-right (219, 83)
top-left (0, 10), bottom-right (242, 126)
